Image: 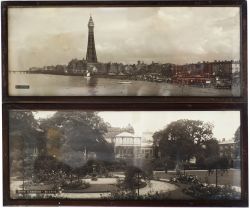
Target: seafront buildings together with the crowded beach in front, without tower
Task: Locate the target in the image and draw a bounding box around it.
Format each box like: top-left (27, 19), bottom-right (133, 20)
top-left (29, 59), bottom-right (241, 87)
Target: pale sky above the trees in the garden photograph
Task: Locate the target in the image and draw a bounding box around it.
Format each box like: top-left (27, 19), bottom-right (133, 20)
top-left (35, 111), bottom-right (240, 140)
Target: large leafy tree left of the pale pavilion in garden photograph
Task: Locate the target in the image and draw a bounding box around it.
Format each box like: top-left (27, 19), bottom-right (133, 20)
top-left (42, 111), bottom-right (112, 167)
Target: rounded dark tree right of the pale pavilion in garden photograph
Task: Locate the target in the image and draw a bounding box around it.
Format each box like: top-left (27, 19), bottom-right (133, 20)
top-left (153, 119), bottom-right (216, 167)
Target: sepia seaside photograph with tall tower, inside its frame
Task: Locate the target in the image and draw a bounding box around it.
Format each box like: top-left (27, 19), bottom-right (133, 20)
top-left (7, 5), bottom-right (242, 97)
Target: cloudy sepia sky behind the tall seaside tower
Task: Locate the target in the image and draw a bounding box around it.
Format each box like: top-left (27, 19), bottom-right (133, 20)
top-left (8, 7), bottom-right (240, 70)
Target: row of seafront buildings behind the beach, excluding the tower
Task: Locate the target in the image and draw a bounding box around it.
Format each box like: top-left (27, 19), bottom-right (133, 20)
top-left (29, 59), bottom-right (240, 77)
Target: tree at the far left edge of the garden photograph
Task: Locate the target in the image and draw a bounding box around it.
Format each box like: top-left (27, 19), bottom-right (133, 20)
top-left (9, 110), bottom-right (44, 175)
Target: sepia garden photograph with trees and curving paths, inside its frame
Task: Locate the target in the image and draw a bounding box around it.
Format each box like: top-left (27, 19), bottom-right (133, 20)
top-left (8, 110), bottom-right (243, 201)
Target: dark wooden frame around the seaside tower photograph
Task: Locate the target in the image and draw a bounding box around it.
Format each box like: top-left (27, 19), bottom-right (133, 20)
top-left (2, 0), bottom-right (247, 103)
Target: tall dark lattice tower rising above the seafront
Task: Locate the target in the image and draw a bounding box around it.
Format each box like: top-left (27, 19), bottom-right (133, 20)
top-left (86, 16), bottom-right (97, 63)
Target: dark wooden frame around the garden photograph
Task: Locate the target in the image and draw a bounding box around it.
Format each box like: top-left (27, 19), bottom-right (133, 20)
top-left (3, 103), bottom-right (248, 206)
